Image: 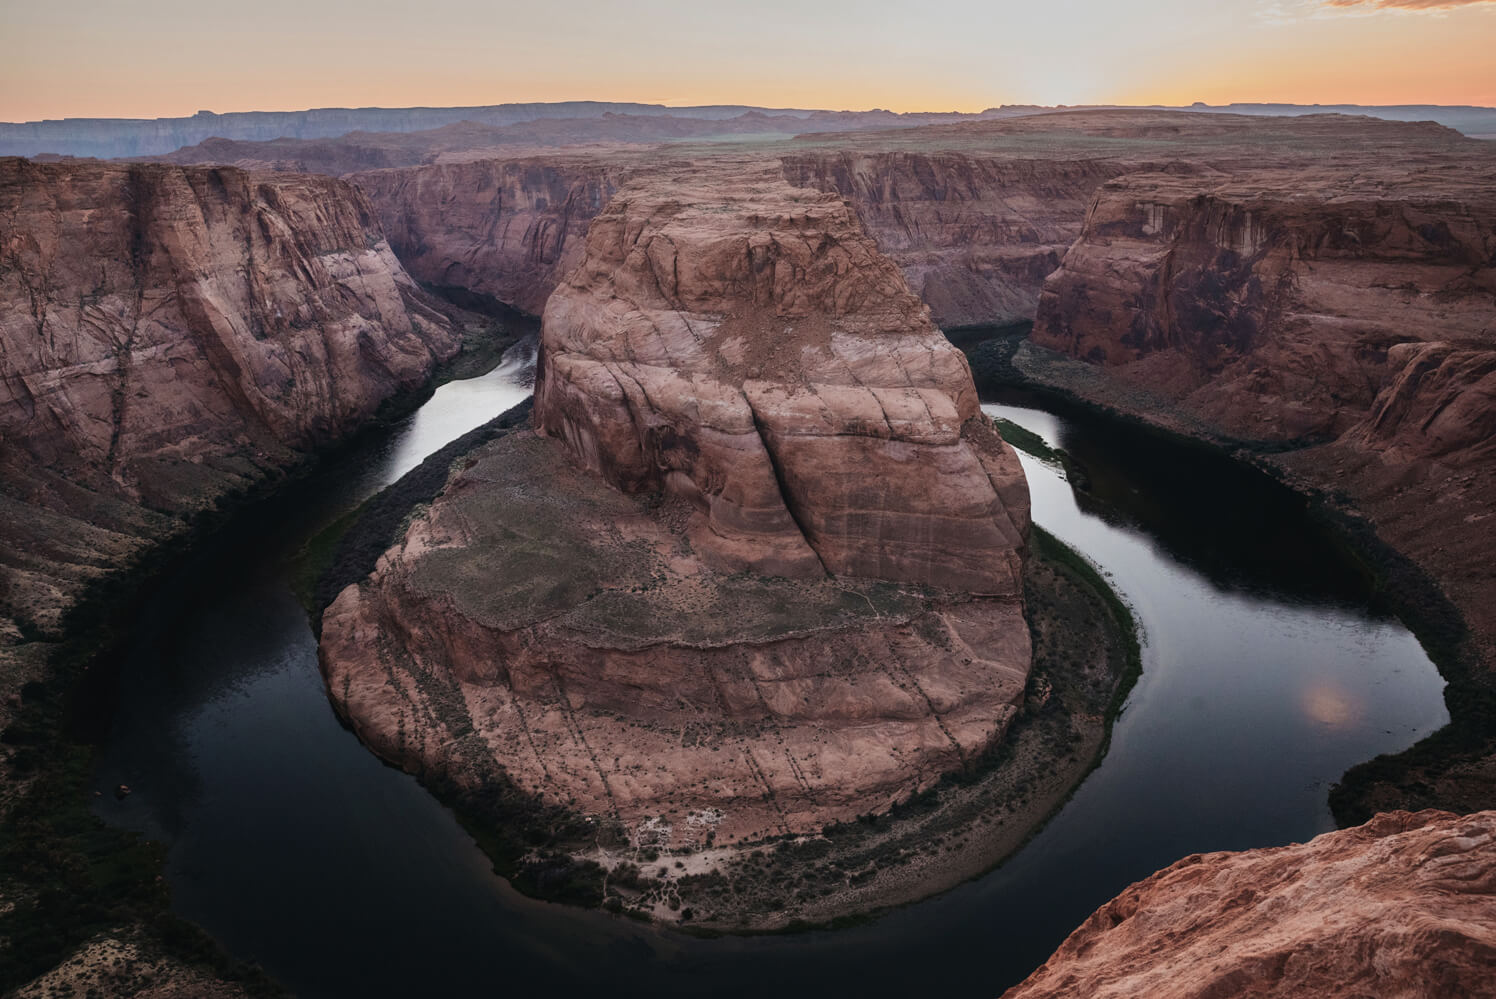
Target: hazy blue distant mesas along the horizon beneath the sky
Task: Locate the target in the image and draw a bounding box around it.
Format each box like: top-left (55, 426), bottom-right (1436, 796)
top-left (0, 100), bottom-right (1496, 159)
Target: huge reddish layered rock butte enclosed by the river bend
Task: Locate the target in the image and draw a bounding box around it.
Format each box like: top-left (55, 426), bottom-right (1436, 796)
top-left (322, 167), bottom-right (1029, 843)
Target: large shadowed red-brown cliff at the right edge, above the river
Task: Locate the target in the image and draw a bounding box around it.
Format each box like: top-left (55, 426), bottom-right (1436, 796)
top-left (1032, 162), bottom-right (1496, 664)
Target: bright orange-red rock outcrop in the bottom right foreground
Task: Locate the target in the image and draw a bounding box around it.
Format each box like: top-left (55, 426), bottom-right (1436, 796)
top-left (1005, 811), bottom-right (1496, 999)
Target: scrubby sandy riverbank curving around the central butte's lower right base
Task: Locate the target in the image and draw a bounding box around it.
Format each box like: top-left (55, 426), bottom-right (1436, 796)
top-left (628, 528), bottom-right (1141, 933)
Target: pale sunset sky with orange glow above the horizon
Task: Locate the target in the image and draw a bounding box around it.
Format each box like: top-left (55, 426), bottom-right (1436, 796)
top-left (0, 0), bottom-right (1496, 121)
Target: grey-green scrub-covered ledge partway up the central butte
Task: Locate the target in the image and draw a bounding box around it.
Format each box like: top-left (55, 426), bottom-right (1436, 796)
top-left (404, 431), bottom-right (953, 649)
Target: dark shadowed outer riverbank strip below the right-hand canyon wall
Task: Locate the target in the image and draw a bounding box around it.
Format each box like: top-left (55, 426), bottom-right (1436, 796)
top-left (965, 331), bottom-right (1496, 827)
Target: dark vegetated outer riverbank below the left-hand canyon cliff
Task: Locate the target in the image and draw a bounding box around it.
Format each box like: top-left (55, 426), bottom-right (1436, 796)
top-left (0, 312), bottom-right (533, 996)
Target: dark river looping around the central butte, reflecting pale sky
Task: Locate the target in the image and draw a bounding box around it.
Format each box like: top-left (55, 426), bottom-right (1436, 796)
top-left (84, 351), bottom-right (1447, 998)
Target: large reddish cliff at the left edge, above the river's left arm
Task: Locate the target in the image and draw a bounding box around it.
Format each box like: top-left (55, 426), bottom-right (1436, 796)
top-left (0, 160), bottom-right (459, 640)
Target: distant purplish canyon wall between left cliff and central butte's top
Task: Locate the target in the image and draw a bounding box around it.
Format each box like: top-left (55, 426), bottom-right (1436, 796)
top-left (349, 157), bottom-right (621, 316)
